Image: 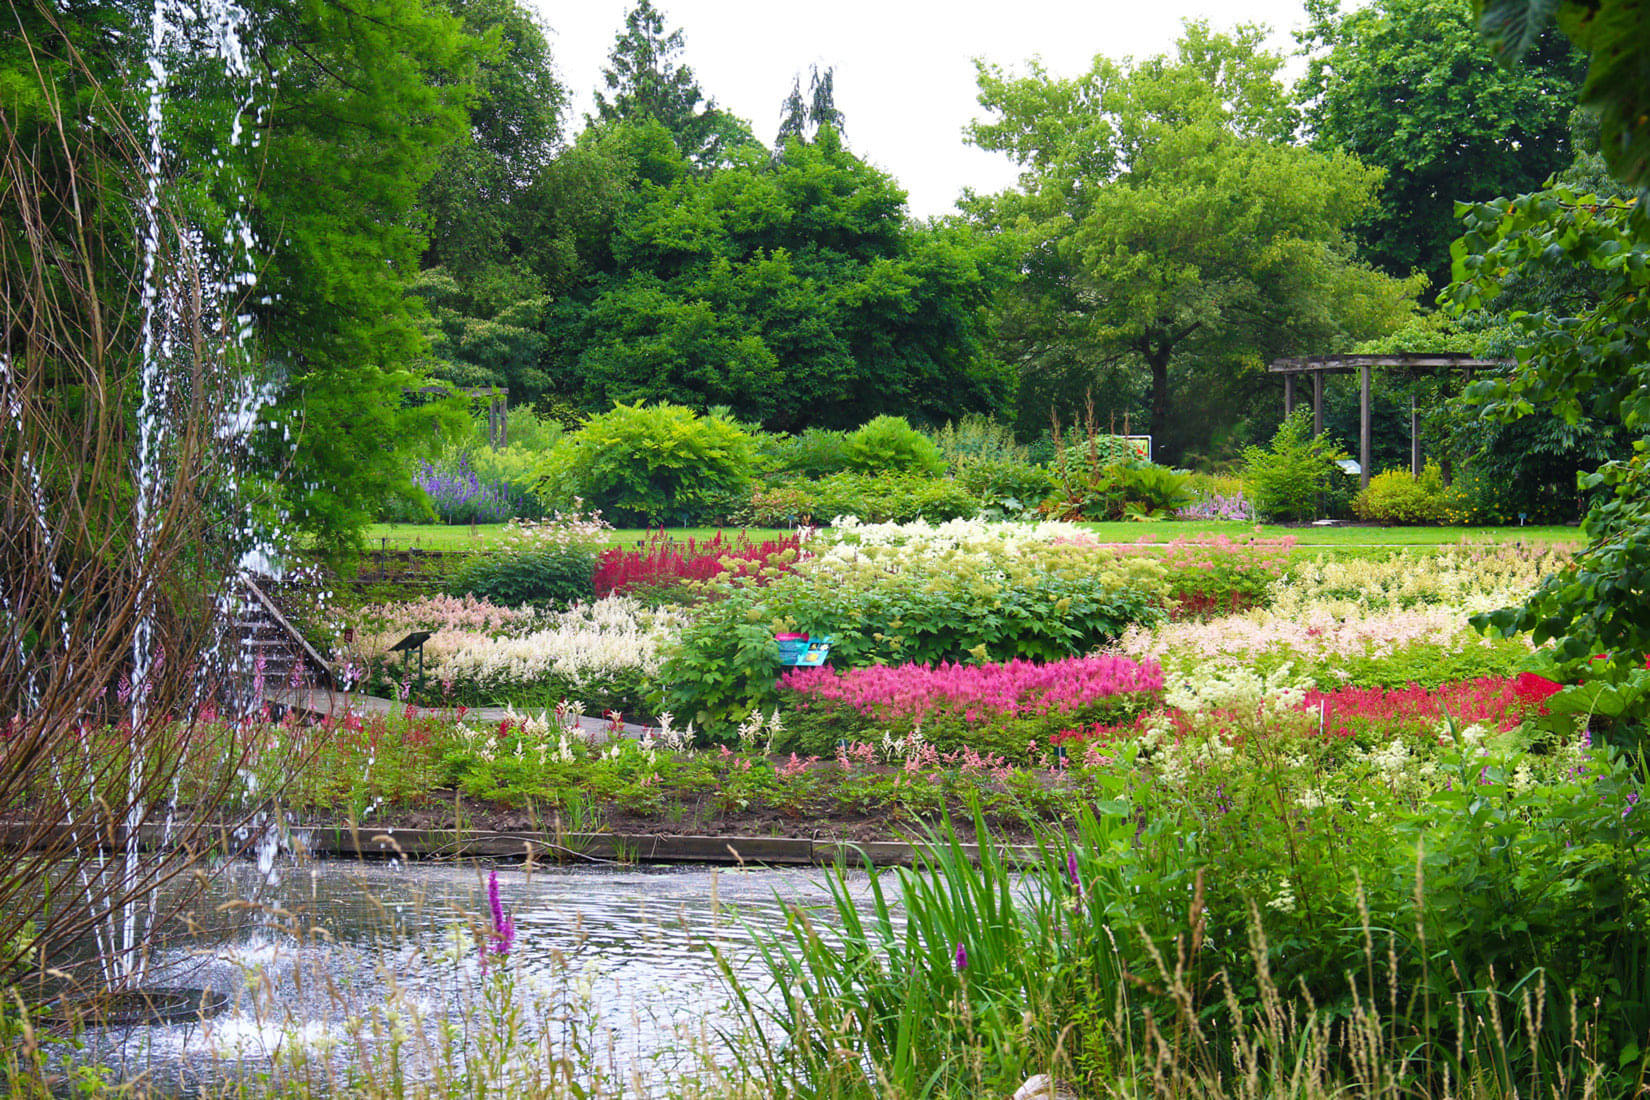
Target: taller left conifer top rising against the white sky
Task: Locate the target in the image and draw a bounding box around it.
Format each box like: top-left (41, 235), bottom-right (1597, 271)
top-left (592, 0), bottom-right (754, 168)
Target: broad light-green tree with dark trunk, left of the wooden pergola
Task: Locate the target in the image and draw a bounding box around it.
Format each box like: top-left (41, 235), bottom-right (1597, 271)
top-left (970, 23), bottom-right (1414, 458)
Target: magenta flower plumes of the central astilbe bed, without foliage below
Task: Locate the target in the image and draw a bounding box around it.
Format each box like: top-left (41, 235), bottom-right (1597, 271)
top-left (780, 656), bottom-right (1163, 721)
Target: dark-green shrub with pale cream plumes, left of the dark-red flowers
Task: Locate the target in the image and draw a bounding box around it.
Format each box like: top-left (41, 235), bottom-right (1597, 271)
top-left (450, 515), bottom-right (611, 607)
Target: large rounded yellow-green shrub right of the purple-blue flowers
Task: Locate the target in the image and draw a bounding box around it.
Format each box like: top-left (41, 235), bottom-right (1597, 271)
top-left (541, 402), bottom-right (752, 524)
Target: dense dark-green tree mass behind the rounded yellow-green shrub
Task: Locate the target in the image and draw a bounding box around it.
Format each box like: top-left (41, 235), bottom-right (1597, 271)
top-left (545, 120), bottom-right (1011, 429)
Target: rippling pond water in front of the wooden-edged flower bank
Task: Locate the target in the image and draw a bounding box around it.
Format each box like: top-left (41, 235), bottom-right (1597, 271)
top-left (51, 861), bottom-right (868, 1095)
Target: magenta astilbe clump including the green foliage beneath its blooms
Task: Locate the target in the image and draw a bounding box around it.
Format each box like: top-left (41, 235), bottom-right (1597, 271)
top-left (779, 656), bottom-right (1163, 759)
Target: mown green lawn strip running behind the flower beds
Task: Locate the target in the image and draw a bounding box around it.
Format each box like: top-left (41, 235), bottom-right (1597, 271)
top-left (366, 519), bottom-right (1582, 551)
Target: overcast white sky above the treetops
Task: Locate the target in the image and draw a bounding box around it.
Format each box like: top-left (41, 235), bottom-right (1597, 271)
top-left (528, 0), bottom-right (1305, 218)
